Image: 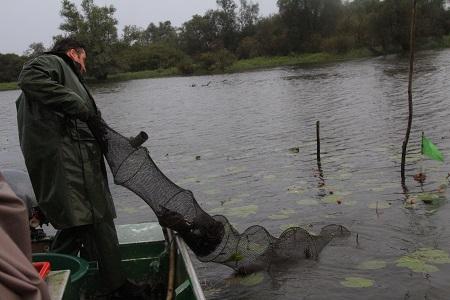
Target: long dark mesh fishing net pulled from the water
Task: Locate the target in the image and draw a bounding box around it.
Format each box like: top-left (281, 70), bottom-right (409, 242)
top-left (89, 118), bottom-right (349, 273)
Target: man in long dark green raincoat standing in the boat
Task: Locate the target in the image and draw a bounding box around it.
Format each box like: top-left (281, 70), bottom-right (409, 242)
top-left (16, 38), bottom-right (146, 299)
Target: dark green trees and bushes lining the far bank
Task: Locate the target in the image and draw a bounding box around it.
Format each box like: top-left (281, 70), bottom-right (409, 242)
top-left (0, 0), bottom-right (450, 82)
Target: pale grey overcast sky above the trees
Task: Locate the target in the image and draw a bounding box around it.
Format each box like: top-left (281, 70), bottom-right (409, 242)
top-left (0, 0), bottom-right (277, 54)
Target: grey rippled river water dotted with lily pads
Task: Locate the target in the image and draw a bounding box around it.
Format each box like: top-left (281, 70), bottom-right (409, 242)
top-left (0, 50), bottom-right (450, 299)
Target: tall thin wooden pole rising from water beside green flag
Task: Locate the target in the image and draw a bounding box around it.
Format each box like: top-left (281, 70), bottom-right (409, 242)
top-left (401, 0), bottom-right (416, 190)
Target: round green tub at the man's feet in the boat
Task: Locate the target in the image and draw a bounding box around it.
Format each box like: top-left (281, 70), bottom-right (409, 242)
top-left (33, 253), bottom-right (89, 300)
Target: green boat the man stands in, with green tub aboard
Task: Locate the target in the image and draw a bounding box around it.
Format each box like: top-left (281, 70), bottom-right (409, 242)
top-left (33, 223), bottom-right (205, 300)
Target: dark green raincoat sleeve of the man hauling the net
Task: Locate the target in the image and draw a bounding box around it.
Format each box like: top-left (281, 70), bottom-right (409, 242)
top-left (19, 56), bottom-right (93, 121)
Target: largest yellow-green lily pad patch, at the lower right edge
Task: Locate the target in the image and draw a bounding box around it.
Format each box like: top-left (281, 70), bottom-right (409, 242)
top-left (396, 248), bottom-right (450, 273)
